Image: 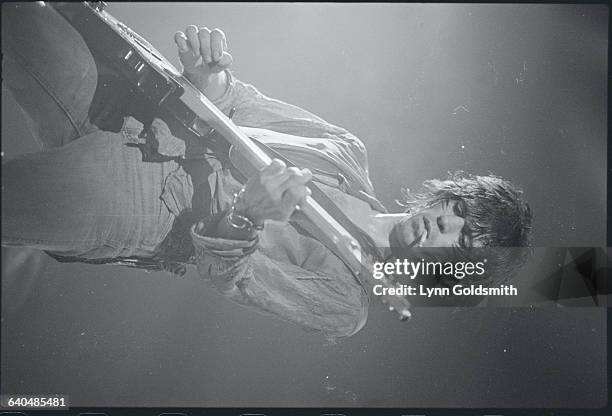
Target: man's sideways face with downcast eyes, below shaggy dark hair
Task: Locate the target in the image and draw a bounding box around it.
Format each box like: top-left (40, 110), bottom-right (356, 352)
top-left (389, 200), bottom-right (476, 248)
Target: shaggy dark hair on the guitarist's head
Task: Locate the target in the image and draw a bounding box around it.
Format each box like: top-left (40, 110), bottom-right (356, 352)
top-left (397, 172), bottom-right (532, 283)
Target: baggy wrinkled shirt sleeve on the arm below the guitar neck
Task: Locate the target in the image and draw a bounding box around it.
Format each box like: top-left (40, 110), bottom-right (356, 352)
top-left (191, 215), bottom-right (368, 338)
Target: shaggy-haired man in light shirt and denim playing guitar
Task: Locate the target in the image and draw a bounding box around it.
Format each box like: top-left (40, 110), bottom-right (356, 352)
top-left (2, 4), bottom-right (531, 337)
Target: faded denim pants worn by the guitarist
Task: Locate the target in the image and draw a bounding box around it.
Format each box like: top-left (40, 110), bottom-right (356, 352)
top-left (2, 2), bottom-right (180, 259)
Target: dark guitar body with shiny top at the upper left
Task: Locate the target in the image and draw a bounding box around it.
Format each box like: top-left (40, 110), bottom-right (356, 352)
top-left (51, 2), bottom-right (228, 152)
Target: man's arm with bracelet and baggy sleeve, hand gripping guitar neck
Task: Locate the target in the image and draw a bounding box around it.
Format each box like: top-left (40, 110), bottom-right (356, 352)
top-left (192, 159), bottom-right (368, 337)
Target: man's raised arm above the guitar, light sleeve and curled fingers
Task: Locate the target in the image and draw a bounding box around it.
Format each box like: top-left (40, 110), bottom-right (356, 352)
top-left (175, 25), bottom-right (373, 193)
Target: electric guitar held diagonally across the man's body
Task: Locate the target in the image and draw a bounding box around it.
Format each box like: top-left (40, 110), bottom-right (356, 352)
top-left (54, 2), bottom-right (411, 320)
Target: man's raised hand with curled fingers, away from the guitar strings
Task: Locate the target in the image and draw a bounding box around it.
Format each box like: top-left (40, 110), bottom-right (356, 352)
top-left (174, 25), bottom-right (232, 101)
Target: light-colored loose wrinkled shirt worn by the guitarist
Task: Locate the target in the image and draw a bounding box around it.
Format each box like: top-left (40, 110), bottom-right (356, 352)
top-left (178, 74), bottom-right (386, 337)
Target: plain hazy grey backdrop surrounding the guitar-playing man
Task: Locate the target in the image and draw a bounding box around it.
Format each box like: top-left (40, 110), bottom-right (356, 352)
top-left (1, 3), bottom-right (608, 407)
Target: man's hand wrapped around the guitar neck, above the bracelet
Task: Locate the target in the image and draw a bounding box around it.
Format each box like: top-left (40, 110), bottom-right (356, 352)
top-left (236, 159), bottom-right (312, 228)
